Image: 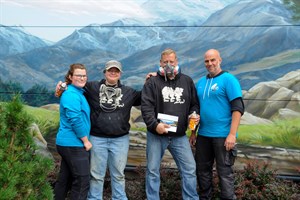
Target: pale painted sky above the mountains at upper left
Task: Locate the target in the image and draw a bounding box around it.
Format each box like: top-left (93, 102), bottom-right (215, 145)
top-left (0, 0), bottom-right (151, 42)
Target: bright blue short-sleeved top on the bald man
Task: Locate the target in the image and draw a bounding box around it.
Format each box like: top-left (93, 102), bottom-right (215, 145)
top-left (196, 72), bottom-right (242, 137)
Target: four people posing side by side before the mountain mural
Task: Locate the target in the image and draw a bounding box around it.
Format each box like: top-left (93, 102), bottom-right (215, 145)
top-left (54, 49), bottom-right (244, 200)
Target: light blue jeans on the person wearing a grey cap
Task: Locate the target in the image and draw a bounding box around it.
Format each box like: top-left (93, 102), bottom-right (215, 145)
top-left (88, 134), bottom-right (129, 200)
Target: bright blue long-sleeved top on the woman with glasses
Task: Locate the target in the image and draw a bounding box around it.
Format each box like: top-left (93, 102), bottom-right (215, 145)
top-left (56, 85), bottom-right (91, 147)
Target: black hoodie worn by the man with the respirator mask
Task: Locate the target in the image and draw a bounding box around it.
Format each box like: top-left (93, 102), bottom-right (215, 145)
top-left (141, 73), bottom-right (199, 136)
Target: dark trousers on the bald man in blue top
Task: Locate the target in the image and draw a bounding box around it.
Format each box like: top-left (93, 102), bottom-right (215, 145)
top-left (195, 136), bottom-right (236, 199)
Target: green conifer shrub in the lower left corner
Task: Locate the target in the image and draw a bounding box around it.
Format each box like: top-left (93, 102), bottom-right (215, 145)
top-left (0, 95), bottom-right (53, 200)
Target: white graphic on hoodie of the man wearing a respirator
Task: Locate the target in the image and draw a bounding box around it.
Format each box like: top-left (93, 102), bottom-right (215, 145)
top-left (161, 86), bottom-right (185, 104)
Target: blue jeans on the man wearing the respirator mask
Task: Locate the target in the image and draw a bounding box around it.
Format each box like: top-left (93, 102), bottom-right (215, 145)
top-left (146, 132), bottom-right (199, 200)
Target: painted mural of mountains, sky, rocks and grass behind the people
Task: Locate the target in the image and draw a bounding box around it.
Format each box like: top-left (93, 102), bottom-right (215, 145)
top-left (0, 0), bottom-right (300, 176)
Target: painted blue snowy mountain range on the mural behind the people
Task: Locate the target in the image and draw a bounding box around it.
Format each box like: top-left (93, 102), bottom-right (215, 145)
top-left (0, 0), bottom-right (300, 89)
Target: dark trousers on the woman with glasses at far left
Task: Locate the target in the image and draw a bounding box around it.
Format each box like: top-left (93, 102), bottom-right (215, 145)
top-left (54, 145), bottom-right (90, 200)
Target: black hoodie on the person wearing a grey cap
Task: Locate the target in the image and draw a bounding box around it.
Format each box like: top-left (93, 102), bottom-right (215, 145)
top-left (85, 79), bottom-right (141, 138)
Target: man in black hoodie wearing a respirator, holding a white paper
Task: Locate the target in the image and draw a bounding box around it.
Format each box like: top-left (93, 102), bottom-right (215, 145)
top-left (141, 49), bottom-right (199, 200)
